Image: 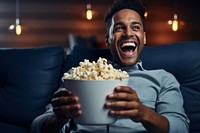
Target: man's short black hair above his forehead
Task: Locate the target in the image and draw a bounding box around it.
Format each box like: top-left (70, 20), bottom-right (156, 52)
top-left (105, 0), bottom-right (147, 33)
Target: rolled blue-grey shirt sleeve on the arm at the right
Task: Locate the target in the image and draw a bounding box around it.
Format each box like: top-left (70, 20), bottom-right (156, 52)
top-left (156, 71), bottom-right (189, 133)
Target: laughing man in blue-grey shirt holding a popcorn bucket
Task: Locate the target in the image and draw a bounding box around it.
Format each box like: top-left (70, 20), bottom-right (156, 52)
top-left (32, 0), bottom-right (189, 133)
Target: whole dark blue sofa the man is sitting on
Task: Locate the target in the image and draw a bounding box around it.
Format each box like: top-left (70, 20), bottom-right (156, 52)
top-left (0, 41), bottom-right (200, 133)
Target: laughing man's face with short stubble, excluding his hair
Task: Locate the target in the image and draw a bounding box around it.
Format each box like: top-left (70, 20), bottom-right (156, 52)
top-left (106, 9), bottom-right (146, 66)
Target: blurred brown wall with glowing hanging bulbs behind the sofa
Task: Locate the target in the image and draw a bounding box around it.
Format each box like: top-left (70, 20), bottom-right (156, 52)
top-left (0, 0), bottom-right (200, 48)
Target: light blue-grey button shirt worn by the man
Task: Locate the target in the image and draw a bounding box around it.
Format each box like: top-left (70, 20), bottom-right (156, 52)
top-left (31, 61), bottom-right (189, 133)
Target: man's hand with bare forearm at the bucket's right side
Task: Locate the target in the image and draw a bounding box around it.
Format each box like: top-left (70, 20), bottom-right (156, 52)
top-left (105, 86), bottom-right (169, 133)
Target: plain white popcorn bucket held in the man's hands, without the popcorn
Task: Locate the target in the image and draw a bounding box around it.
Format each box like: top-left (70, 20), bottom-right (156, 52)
top-left (64, 79), bottom-right (128, 125)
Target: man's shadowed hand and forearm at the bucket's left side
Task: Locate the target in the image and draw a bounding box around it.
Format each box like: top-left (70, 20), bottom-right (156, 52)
top-left (41, 89), bottom-right (81, 133)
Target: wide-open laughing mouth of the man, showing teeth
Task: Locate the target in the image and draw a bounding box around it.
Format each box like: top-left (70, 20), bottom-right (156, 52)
top-left (121, 42), bottom-right (136, 54)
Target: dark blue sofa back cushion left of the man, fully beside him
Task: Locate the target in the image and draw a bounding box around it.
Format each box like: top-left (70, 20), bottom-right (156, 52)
top-left (0, 46), bottom-right (65, 131)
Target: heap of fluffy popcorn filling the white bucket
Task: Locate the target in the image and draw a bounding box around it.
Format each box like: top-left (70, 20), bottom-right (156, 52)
top-left (63, 57), bottom-right (129, 80)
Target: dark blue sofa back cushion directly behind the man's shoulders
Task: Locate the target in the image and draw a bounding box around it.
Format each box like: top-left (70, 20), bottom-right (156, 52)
top-left (65, 41), bottom-right (200, 132)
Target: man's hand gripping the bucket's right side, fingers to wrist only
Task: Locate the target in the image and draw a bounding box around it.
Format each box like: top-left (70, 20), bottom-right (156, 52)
top-left (105, 86), bottom-right (142, 117)
